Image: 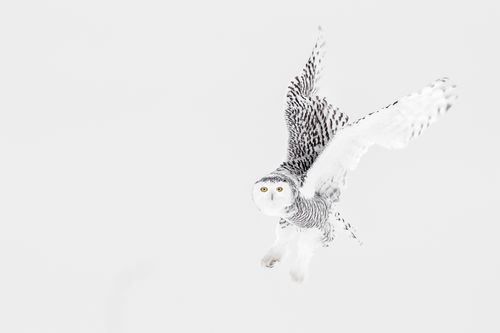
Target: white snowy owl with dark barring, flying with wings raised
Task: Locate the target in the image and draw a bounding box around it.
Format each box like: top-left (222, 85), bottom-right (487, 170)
top-left (253, 28), bottom-right (456, 282)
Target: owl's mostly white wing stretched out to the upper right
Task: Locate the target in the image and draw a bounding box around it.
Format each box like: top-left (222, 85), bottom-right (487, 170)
top-left (301, 78), bottom-right (457, 197)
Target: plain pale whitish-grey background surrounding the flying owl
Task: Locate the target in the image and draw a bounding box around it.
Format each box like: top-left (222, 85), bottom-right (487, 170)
top-left (0, 0), bottom-right (500, 333)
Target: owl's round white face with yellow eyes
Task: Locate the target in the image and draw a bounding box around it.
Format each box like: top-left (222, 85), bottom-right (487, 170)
top-left (253, 180), bottom-right (295, 217)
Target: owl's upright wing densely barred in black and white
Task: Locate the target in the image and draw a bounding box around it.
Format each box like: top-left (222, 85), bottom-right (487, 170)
top-left (283, 28), bottom-right (348, 175)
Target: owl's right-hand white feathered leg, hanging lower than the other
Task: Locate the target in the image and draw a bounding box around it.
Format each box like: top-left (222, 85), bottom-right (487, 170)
top-left (290, 228), bottom-right (323, 283)
